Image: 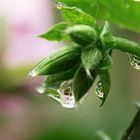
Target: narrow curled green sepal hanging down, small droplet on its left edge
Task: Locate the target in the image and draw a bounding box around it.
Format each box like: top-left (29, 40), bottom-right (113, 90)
top-left (98, 70), bottom-right (111, 106)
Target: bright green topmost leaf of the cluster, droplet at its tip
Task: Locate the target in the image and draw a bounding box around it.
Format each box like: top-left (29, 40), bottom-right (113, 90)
top-left (57, 6), bottom-right (95, 26)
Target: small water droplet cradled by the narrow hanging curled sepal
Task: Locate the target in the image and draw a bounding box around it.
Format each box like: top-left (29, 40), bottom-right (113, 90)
top-left (95, 81), bottom-right (104, 98)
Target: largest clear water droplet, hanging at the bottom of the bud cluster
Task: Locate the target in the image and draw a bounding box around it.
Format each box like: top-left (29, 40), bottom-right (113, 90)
top-left (59, 82), bottom-right (75, 108)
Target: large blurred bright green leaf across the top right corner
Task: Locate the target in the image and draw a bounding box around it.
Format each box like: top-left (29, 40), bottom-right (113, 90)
top-left (56, 0), bottom-right (140, 32)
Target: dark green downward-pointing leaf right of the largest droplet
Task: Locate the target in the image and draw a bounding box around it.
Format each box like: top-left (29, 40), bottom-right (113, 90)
top-left (72, 67), bottom-right (96, 102)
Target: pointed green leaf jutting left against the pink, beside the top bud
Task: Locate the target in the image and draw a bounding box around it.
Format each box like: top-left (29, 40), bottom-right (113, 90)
top-left (39, 22), bottom-right (69, 41)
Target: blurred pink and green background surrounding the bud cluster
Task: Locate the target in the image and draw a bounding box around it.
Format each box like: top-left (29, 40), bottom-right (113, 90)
top-left (0, 0), bottom-right (140, 140)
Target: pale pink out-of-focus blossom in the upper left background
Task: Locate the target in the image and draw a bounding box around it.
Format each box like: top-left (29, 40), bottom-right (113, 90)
top-left (0, 0), bottom-right (57, 67)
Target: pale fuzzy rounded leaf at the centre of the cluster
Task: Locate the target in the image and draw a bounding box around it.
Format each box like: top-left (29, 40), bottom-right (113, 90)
top-left (81, 46), bottom-right (103, 70)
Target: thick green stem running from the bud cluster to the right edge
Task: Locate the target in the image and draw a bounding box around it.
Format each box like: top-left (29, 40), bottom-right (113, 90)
top-left (105, 36), bottom-right (140, 57)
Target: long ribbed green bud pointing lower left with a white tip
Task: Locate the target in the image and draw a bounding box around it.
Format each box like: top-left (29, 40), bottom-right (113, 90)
top-left (29, 45), bottom-right (81, 77)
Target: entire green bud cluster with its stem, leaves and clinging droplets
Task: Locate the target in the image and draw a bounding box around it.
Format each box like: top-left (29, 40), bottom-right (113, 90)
top-left (30, 3), bottom-right (140, 108)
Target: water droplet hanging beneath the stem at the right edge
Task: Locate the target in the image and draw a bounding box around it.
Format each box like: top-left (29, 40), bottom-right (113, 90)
top-left (128, 54), bottom-right (140, 70)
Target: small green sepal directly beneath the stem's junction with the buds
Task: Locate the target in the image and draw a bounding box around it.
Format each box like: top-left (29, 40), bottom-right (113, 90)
top-left (98, 52), bottom-right (113, 70)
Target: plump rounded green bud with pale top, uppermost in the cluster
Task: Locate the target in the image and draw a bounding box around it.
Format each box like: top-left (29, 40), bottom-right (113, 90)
top-left (66, 25), bottom-right (97, 47)
